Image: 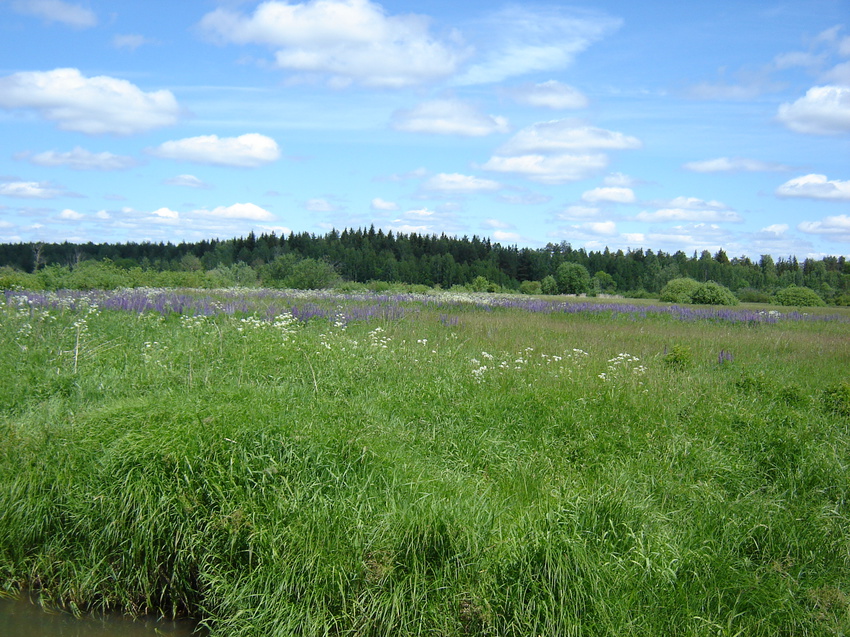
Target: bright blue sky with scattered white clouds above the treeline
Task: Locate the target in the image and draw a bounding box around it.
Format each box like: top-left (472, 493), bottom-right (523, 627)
top-left (0, 0), bottom-right (850, 259)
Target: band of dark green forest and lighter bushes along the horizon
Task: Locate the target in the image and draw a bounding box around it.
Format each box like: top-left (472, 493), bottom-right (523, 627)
top-left (0, 226), bottom-right (850, 305)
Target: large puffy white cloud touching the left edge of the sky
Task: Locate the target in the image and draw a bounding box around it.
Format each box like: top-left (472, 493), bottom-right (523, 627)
top-left (0, 68), bottom-right (179, 135)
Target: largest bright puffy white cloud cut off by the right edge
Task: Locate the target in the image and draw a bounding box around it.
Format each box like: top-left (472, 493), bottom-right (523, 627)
top-left (778, 86), bottom-right (850, 135)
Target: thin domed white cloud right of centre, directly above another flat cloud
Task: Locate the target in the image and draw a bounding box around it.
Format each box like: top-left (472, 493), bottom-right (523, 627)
top-left (496, 119), bottom-right (642, 155)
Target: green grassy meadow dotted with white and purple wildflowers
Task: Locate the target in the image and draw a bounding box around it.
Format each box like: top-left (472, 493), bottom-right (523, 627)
top-left (0, 291), bottom-right (850, 637)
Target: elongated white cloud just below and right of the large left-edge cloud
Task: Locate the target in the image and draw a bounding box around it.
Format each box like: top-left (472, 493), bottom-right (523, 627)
top-left (149, 133), bottom-right (280, 168)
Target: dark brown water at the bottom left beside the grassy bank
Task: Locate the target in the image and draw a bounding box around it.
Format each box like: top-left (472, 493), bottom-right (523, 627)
top-left (0, 598), bottom-right (204, 637)
